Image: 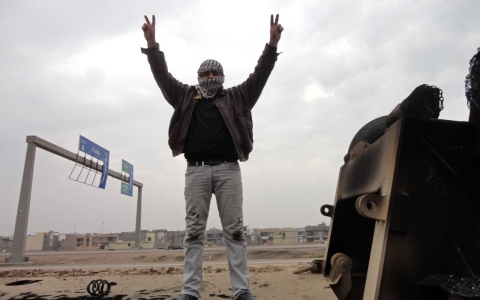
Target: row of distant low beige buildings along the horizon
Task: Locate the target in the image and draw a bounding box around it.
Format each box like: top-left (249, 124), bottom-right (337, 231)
top-left (8, 223), bottom-right (329, 251)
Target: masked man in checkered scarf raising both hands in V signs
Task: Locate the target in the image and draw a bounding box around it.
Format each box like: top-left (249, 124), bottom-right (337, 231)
top-left (142, 15), bottom-right (283, 300)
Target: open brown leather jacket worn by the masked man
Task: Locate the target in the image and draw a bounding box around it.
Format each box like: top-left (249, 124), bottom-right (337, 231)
top-left (142, 44), bottom-right (278, 161)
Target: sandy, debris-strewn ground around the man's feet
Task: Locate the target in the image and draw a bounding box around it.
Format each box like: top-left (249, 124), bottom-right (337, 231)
top-left (0, 249), bottom-right (336, 300)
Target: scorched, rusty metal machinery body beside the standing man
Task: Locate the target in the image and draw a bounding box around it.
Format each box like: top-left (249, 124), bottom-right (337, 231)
top-left (317, 117), bottom-right (480, 300)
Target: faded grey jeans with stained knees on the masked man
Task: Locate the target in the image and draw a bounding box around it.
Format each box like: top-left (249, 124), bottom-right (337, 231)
top-left (182, 162), bottom-right (250, 298)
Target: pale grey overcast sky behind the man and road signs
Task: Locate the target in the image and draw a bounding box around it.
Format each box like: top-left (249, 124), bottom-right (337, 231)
top-left (0, 0), bottom-right (480, 235)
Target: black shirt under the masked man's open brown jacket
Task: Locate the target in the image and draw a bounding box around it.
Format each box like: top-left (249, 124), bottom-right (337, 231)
top-left (183, 93), bottom-right (238, 161)
